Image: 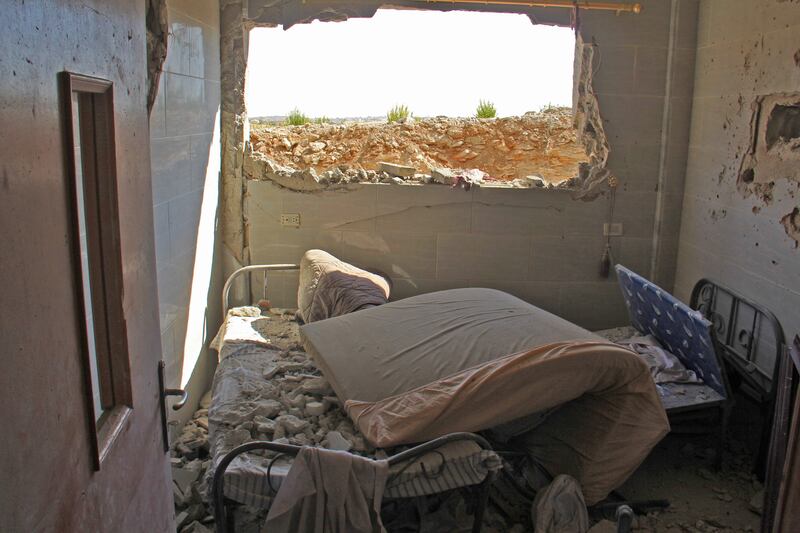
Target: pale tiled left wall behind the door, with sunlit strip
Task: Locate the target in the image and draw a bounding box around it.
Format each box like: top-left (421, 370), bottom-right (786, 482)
top-left (150, 0), bottom-right (220, 412)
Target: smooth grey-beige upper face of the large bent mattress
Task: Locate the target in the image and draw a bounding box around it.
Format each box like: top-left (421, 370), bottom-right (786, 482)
top-left (300, 288), bottom-right (602, 402)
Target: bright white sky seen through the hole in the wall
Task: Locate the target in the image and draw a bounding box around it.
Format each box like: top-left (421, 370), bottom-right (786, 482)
top-left (245, 9), bottom-right (575, 118)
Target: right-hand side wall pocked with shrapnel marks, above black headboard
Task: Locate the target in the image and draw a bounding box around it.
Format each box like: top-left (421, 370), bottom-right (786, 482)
top-left (676, 0), bottom-right (800, 344)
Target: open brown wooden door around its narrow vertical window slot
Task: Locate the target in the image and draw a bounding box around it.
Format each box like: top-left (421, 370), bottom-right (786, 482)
top-left (0, 0), bottom-right (174, 533)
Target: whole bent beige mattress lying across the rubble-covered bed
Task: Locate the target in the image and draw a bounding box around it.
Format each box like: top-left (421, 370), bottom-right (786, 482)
top-left (301, 289), bottom-right (669, 504)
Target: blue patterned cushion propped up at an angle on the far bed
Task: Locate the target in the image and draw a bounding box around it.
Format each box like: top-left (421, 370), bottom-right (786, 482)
top-left (616, 265), bottom-right (727, 398)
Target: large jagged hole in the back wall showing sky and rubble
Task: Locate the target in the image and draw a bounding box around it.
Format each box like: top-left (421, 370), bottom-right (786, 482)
top-left (245, 10), bottom-right (607, 190)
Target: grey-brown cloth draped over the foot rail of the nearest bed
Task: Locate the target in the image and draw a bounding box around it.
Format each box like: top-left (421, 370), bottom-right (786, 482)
top-left (262, 447), bottom-right (389, 533)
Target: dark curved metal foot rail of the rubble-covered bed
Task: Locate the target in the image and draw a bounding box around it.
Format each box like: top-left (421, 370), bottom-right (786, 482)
top-left (211, 433), bottom-right (496, 533)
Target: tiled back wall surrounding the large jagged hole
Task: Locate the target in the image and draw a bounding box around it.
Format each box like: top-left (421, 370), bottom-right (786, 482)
top-left (222, 0), bottom-right (697, 327)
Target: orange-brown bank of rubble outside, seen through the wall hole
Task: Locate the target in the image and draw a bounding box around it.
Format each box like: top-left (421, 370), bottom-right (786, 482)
top-left (250, 108), bottom-right (588, 187)
